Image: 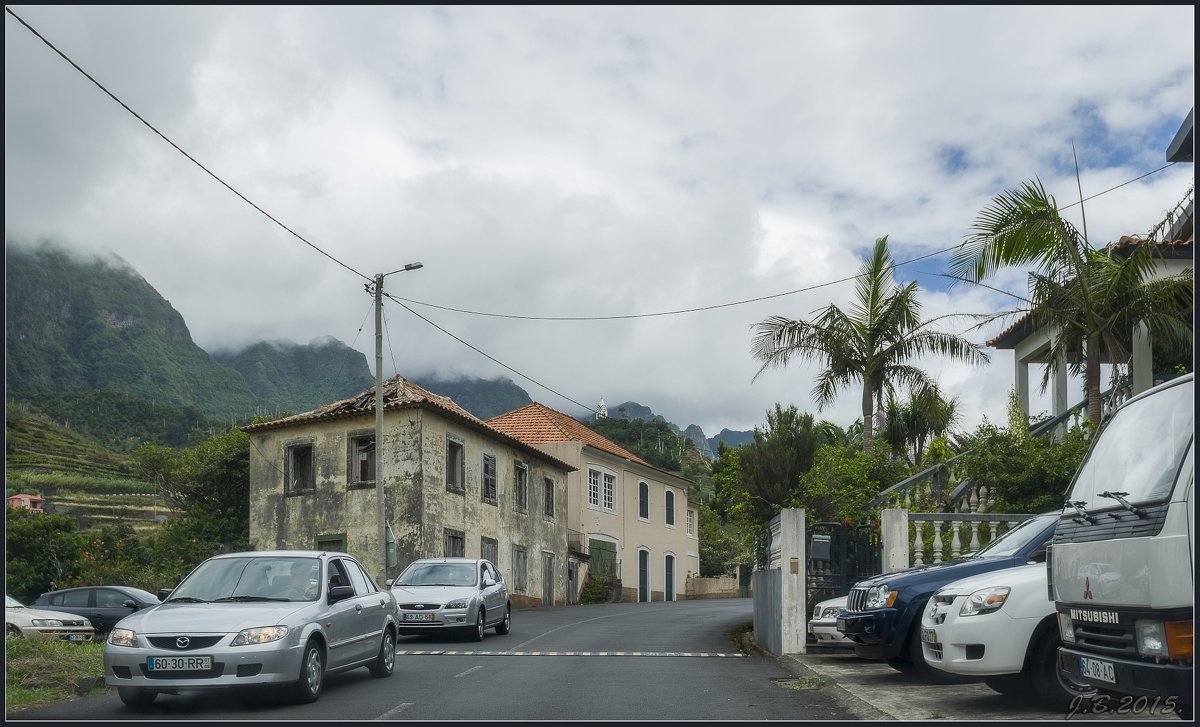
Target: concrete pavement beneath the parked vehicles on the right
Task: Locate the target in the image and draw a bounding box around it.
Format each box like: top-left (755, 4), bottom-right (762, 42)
top-left (779, 644), bottom-right (1178, 722)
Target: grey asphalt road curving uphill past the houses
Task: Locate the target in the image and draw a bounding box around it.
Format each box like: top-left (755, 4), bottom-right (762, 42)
top-left (6, 599), bottom-right (857, 722)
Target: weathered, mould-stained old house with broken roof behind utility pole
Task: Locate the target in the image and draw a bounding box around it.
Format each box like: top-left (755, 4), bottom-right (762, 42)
top-left (242, 377), bottom-right (575, 607)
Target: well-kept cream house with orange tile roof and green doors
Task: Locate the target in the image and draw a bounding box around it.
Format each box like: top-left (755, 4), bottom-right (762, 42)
top-left (487, 403), bottom-right (700, 601)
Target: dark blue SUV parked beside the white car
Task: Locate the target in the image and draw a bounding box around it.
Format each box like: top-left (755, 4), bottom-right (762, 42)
top-left (838, 512), bottom-right (1060, 681)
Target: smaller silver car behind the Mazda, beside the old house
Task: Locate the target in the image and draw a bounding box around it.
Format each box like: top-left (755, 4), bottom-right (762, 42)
top-left (391, 558), bottom-right (512, 641)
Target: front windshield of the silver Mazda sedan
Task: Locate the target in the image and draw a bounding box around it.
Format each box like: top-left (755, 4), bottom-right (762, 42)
top-left (167, 555), bottom-right (320, 603)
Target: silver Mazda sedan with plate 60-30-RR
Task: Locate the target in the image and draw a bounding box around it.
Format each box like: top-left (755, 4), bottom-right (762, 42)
top-left (104, 551), bottom-right (396, 705)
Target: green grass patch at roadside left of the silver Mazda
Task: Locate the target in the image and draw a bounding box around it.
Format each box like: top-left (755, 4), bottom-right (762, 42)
top-left (4, 638), bottom-right (108, 713)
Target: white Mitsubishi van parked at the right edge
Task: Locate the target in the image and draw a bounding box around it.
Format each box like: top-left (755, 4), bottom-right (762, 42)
top-left (1046, 374), bottom-right (1195, 720)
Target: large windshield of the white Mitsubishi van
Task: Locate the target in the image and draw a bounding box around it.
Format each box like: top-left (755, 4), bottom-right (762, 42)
top-left (1070, 380), bottom-right (1195, 512)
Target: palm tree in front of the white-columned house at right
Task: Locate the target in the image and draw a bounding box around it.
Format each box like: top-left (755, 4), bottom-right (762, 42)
top-left (950, 180), bottom-right (1193, 423)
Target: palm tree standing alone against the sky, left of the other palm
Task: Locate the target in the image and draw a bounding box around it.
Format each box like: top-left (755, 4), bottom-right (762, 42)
top-left (750, 236), bottom-right (988, 451)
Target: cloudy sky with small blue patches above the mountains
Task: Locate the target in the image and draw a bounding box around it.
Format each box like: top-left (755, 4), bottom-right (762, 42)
top-left (5, 5), bottom-right (1195, 435)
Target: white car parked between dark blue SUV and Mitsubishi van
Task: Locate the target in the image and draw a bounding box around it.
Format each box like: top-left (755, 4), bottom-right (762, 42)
top-left (920, 563), bottom-right (1096, 711)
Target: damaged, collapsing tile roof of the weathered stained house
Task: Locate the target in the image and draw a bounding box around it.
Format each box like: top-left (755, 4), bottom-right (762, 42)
top-left (241, 375), bottom-right (576, 471)
